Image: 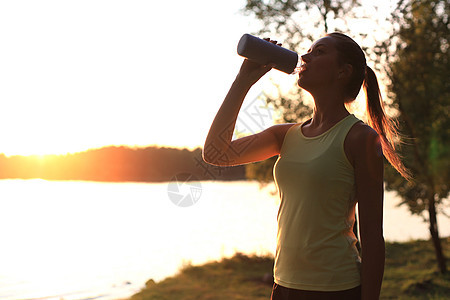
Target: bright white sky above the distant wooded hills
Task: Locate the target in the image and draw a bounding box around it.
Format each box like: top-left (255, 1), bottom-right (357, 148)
top-left (0, 0), bottom-right (392, 155)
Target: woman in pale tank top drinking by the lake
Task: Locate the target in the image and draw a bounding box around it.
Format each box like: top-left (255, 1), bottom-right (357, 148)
top-left (203, 33), bottom-right (408, 300)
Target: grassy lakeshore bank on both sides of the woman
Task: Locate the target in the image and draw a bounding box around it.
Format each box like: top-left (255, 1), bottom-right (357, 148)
top-left (131, 238), bottom-right (450, 300)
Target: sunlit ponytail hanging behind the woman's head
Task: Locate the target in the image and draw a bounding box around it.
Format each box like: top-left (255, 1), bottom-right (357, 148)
top-left (364, 66), bottom-right (411, 180)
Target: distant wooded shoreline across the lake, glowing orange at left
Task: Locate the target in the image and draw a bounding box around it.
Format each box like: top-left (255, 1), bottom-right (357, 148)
top-left (0, 146), bottom-right (246, 183)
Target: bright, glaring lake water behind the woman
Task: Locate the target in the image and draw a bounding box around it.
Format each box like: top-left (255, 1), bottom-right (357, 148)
top-left (0, 179), bottom-right (450, 300)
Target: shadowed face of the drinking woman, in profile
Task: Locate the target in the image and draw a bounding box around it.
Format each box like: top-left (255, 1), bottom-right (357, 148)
top-left (298, 36), bottom-right (339, 93)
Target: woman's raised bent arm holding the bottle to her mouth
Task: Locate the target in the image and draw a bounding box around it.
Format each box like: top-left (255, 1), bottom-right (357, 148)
top-left (203, 59), bottom-right (293, 166)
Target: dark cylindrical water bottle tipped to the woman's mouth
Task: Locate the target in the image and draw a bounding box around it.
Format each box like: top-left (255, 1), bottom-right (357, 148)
top-left (237, 33), bottom-right (298, 74)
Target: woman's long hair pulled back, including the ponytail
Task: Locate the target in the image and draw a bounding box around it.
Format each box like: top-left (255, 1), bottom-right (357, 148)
top-left (328, 32), bottom-right (411, 180)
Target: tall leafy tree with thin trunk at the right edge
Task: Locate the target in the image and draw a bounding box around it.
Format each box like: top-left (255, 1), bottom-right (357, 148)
top-left (380, 0), bottom-right (450, 273)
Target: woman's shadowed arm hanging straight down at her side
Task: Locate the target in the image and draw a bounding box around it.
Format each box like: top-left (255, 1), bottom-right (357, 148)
top-left (349, 123), bottom-right (385, 300)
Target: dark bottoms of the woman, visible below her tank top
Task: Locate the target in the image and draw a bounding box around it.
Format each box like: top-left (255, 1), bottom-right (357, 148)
top-left (270, 283), bottom-right (361, 300)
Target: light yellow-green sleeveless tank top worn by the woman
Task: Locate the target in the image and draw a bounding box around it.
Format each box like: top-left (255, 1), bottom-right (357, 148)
top-left (274, 115), bottom-right (361, 291)
